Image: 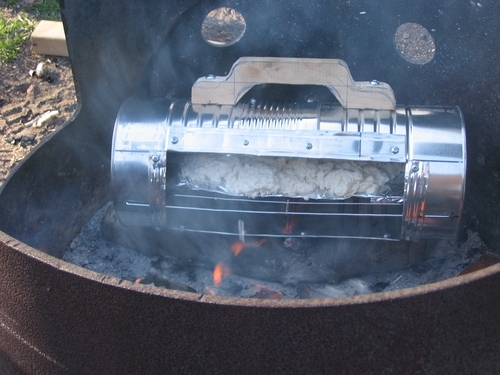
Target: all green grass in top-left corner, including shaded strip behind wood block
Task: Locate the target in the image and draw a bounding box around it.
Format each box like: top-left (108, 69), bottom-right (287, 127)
top-left (0, 0), bottom-right (61, 63)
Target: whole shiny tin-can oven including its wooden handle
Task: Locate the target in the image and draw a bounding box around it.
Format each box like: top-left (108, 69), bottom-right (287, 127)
top-left (112, 58), bottom-right (466, 241)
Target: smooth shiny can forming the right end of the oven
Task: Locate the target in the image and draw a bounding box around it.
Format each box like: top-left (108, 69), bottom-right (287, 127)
top-left (403, 107), bottom-right (466, 239)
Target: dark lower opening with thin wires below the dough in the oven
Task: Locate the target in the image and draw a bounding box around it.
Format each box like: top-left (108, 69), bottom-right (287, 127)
top-left (165, 187), bottom-right (403, 240)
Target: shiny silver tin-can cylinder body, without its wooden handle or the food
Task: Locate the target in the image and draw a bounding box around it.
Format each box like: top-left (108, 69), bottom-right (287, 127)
top-left (112, 99), bottom-right (465, 241)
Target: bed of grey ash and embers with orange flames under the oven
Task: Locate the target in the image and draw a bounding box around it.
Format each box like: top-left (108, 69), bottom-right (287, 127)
top-left (63, 203), bottom-right (492, 299)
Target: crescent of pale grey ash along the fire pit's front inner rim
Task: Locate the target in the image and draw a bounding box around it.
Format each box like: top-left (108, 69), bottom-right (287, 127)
top-left (63, 204), bottom-right (488, 299)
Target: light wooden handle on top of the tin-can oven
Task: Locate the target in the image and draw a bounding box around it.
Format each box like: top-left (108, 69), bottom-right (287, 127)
top-left (191, 57), bottom-right (396, 110)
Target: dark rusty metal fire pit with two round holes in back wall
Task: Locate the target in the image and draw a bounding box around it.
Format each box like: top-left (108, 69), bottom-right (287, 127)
top-left (0, 0), bottom-right (500, 374)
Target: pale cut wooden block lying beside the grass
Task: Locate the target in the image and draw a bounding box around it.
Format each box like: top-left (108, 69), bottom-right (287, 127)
top-left (31, 20), bottom-right (69, 57)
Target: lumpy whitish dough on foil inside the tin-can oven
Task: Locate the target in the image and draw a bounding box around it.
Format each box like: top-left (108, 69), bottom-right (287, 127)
top-left (181, 154), bottom-right (404, 199)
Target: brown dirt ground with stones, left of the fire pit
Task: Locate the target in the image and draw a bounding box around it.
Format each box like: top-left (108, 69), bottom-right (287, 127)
top-left (0, 5), bottom-right (77, 184)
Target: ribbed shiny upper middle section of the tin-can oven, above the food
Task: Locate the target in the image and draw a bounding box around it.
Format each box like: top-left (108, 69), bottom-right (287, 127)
top-left (166, 101), bottom-right (406, 162)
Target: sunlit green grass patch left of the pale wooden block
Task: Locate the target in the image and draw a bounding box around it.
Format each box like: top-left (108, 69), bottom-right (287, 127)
top-left (0, 14), bottom-right (35, 62)
